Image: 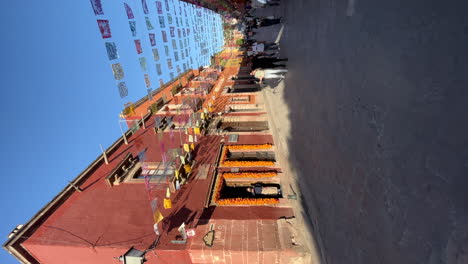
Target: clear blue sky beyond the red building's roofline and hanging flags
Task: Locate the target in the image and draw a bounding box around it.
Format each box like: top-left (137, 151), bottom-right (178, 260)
top-left (0, 0), bottom-right (222, 263)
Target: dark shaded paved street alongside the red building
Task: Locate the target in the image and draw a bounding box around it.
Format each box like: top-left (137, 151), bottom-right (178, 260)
top-left (257, 0), bottom-right (468, 263)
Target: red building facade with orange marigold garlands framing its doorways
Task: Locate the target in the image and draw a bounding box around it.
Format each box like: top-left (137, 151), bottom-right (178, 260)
top-left (4, 55), bottom-right (309, 264)
